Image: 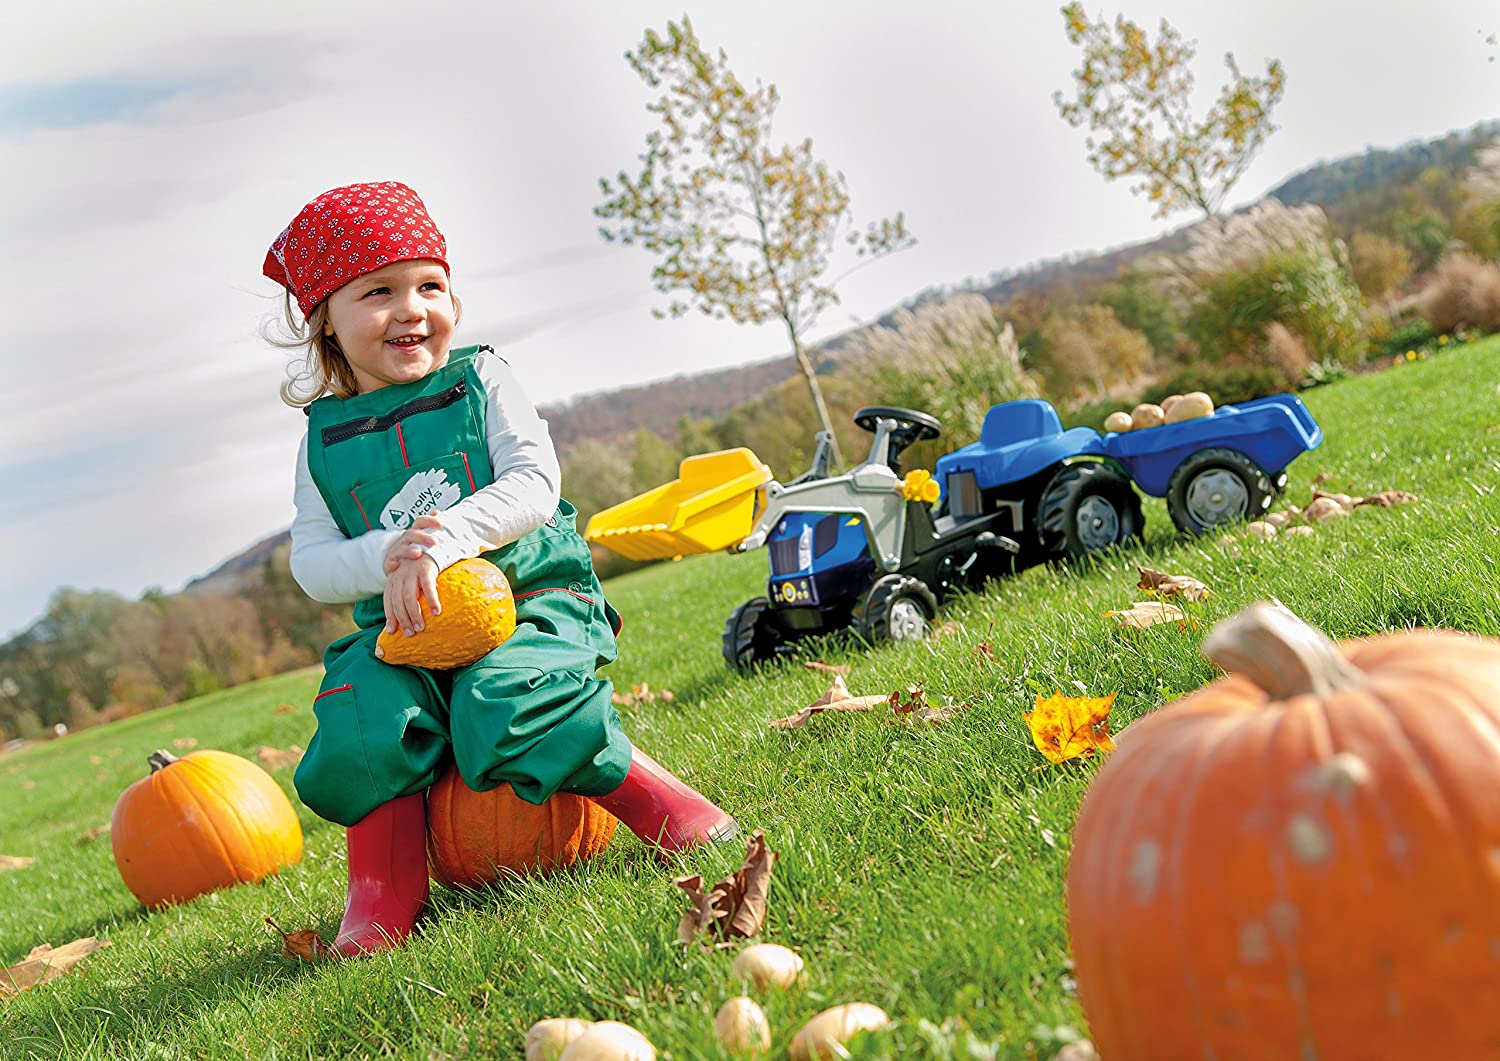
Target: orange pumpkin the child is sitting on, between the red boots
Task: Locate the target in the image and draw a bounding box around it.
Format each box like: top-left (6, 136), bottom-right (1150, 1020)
top-left (428, 767), bottom-right (620, 888)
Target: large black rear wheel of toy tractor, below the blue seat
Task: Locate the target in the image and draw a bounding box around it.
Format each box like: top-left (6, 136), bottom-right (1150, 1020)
top-left (1037, 464), bottom-right (1145, 560)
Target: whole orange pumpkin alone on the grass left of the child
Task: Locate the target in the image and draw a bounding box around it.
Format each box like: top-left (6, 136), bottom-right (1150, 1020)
top-left (110, 750), bottom-right (302, 909)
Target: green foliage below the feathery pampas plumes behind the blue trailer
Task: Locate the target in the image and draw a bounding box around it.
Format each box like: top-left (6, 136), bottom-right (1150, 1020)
top-left (1188, 249), bottom-right (1365, 363)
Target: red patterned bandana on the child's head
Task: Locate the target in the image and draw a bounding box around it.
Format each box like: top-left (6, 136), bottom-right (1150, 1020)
top-left (261, 182), bottom-right (449, 317)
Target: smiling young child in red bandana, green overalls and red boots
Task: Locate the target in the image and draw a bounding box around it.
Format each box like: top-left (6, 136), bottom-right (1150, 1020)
top-left (264, 183), bottom-right (735, 956)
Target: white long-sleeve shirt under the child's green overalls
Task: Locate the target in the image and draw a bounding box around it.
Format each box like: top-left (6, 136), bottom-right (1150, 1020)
top-left (291, 350), bottom-right (563, 605)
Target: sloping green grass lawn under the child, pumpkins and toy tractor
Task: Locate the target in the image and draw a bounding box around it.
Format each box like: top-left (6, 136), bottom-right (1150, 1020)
top-left (0, 339), bottom-right (1500, 1059)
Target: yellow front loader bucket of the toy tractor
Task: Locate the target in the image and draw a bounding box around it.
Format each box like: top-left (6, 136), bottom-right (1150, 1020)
top-left (584, 446), bottom-right (771, 560)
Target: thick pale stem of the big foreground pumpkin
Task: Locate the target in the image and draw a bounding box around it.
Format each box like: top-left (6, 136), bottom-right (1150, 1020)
top-left (1203, 602), bottom-right (1365, 699)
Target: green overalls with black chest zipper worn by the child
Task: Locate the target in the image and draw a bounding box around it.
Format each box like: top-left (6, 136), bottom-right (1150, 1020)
top-left (296, 347), bottom-right (630, 825)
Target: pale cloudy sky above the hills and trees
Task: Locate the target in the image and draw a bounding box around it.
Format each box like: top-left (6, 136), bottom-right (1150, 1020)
top-left (0, 0), bottom-right (1500, 639)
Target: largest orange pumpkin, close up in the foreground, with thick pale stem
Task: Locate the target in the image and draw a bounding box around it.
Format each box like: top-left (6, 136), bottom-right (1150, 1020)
top-left (1068, 605), bottom-right (1500, 1061)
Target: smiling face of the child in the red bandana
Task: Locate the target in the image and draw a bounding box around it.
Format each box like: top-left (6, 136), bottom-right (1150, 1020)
top-left (326, 260), bottom-right (455, 395)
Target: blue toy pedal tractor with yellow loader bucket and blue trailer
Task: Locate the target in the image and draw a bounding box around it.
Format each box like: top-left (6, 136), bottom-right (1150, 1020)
top-left (585, 395), bottom-right (1322, 669)
